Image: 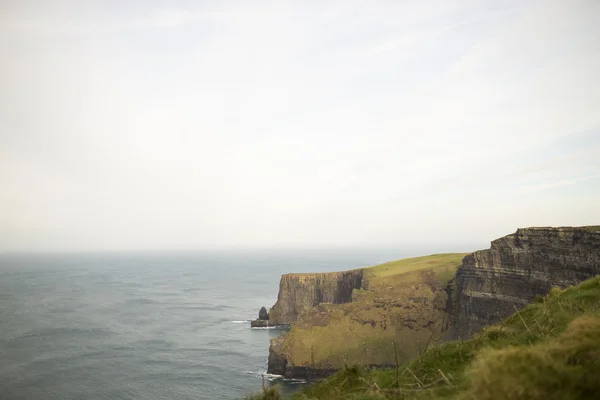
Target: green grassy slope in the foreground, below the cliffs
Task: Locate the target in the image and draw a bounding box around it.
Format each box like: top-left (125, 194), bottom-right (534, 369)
top-left (246, 276), bottom-right (600, 400)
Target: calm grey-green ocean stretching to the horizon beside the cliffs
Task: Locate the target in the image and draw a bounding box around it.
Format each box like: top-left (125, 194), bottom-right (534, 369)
top-left (0, 250), bottom-right (414, 400)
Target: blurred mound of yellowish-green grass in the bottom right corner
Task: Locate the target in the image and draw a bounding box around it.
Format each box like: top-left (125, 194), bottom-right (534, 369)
top-left (465, 316), bottom-right (600, 400)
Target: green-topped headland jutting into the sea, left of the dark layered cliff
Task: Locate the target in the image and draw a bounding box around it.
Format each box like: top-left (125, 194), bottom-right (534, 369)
top-left (268, 254), bottom-right (464, 379)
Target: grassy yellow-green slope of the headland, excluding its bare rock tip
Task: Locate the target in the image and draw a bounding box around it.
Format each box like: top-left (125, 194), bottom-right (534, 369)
top-left (274, 253), bottom-right (465, 369)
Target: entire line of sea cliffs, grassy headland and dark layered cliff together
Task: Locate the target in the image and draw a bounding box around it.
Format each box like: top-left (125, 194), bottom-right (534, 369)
top-left (268, 226), bottom-right (600, 379)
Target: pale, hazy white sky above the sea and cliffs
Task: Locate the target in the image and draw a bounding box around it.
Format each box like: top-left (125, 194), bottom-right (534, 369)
top-left (0, 0), bottom-right (600, 252)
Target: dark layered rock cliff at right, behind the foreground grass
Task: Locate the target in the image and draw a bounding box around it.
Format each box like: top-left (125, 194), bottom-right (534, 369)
top-left (448, 226), bottom-right (600, 338)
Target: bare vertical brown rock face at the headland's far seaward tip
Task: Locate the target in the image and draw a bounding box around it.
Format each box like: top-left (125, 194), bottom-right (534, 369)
top-left (269, 269), bottom-right (363, 325)
